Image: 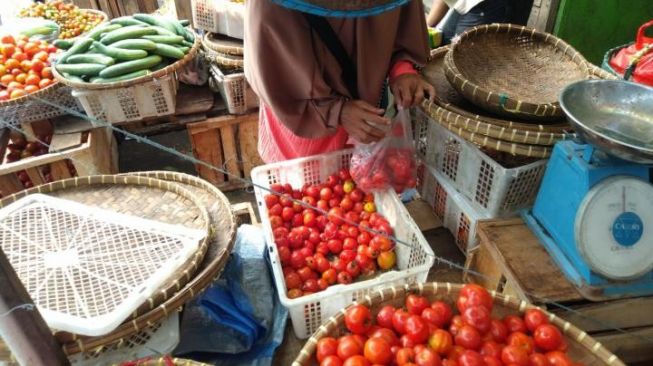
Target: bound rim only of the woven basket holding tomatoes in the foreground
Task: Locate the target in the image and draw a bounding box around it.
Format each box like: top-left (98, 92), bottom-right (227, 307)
top-left (292, 282), bottom-right (626, 366)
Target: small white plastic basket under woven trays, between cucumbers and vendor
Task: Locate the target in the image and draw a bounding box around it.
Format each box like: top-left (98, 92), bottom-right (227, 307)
top-left (210, 64), bottom-right (259, 114)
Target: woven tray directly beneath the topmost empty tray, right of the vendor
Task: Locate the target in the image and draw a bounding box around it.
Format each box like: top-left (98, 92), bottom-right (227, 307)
top-left (422, 46), bottom-right (570, 134)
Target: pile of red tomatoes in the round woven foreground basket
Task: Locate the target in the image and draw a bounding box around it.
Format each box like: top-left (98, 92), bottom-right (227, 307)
top-left (316, 284), bottom-right (578, 366)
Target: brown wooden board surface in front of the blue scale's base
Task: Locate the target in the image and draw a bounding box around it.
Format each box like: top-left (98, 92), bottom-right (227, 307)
top-left (477, 218), bottom-right (583, 303)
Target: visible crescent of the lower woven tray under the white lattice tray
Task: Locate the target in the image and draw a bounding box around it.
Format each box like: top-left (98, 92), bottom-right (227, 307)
top-left (55, 171), bottom-right (237, 355)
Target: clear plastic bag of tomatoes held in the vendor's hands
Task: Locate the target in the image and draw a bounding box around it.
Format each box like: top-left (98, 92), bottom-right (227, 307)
top-left (350, 109), bottom-right (417, 193)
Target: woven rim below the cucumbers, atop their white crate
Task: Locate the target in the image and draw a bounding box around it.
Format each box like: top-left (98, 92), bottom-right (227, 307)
top-left (52, 29), bottom-right (201, 90)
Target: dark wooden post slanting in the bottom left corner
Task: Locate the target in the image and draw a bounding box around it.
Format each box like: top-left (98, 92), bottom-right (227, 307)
top-left (0, 249), bottom-right (70, 366)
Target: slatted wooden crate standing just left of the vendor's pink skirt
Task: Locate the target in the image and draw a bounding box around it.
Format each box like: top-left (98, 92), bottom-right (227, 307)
top-left (186, 112), bottom-right (263, 191)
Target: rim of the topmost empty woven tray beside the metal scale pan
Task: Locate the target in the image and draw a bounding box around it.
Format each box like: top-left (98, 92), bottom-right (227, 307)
top-left (445, 23), bottom-right (589, 119)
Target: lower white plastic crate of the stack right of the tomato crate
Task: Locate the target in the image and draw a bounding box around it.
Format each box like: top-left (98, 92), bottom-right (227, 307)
top-left (418, 164), bottom-right (490, 256)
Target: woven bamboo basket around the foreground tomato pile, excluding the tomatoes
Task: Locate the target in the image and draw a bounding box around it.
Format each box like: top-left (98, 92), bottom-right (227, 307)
top-left (292, 282), bottom-right (625, 366)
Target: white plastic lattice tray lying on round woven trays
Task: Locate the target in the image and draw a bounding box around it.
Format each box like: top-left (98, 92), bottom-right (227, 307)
top-left (0, 194), bottom-right (207, 336)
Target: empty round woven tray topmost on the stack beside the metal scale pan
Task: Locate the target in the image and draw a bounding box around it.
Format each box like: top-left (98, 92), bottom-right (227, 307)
top-left (445, 24), bottom-right (589, 120)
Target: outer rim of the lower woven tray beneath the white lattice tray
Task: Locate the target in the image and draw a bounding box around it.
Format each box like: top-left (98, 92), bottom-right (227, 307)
top-left (57, 171), bottom-right (238, 355)
